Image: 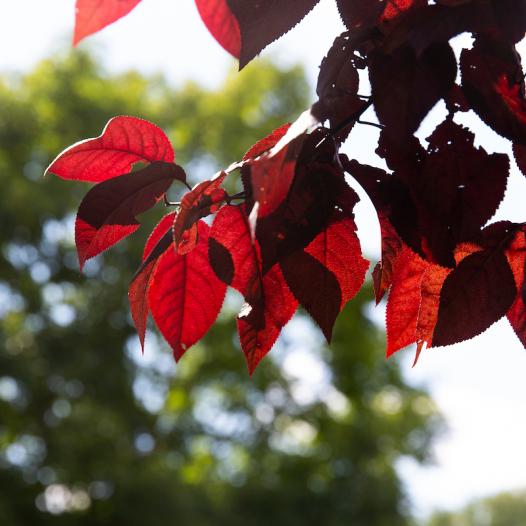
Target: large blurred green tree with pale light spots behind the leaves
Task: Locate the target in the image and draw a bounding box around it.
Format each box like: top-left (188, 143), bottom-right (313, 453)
top-left (0, 52), bottom-right (440, 526)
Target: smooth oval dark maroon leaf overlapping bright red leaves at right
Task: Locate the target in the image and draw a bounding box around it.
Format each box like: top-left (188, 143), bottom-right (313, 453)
top-left (433, 242), bottom-right (516, 346)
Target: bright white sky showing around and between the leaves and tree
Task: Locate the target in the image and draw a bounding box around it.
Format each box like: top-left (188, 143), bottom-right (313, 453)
top-left (0, 0), bottom-right (526, 514)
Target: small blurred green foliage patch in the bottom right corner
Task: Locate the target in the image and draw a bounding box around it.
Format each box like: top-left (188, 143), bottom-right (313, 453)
top-left (428, 491), bottom-right (526, 526)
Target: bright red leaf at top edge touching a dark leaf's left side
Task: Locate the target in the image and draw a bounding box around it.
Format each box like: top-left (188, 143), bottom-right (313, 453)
top-left (195, 0), bottom-right (241, 58)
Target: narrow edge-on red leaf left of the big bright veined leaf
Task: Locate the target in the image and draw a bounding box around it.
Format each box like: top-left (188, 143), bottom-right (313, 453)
top-left (128, 213), bottom-right (175, 351)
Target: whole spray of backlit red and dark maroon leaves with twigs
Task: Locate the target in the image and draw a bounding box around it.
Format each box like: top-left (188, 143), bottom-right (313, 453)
top-left (54, 0), bottom-right (526, 372)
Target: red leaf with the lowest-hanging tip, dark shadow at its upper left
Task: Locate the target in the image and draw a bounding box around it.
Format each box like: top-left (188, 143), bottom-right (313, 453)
top-left (237, 265), bottom-right (298, 375)
